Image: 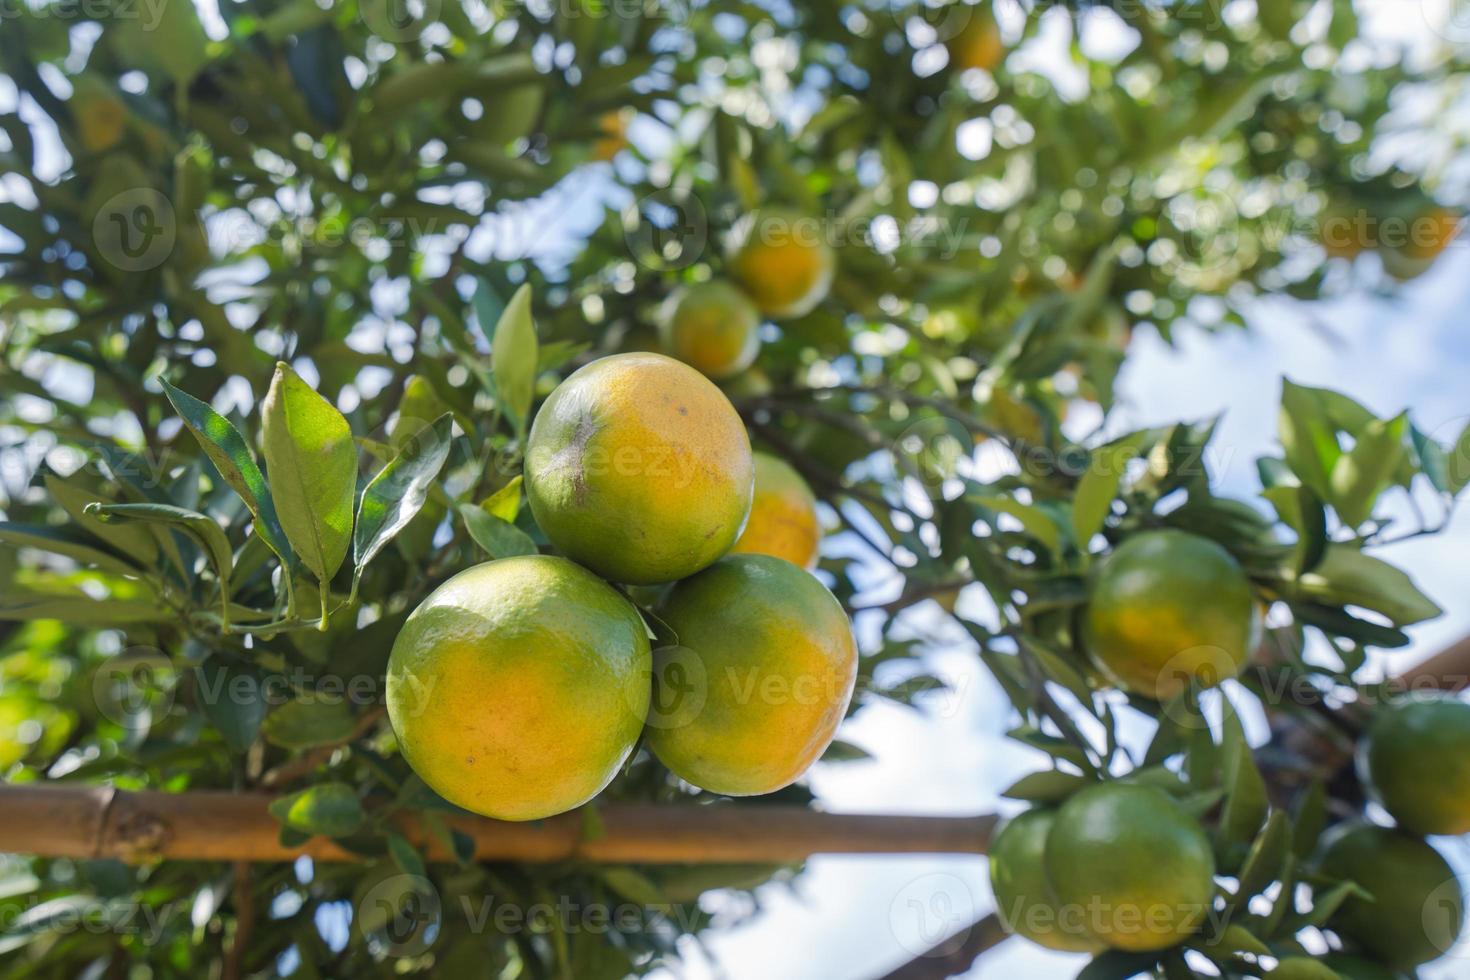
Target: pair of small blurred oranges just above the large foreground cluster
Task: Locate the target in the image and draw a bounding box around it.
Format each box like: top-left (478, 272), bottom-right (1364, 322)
top-left (660, 209), bottom-right (836, 379)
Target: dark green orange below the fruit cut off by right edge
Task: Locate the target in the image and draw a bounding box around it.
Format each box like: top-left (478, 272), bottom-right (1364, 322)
top-left (1322, 823), bottom-right (1464, 970)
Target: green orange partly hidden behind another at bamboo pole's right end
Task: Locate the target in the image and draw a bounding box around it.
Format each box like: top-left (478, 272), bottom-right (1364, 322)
top-left (988, 808), bottom-right (1103, 952)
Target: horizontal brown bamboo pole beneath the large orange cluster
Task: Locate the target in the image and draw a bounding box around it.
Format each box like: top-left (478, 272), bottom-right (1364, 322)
top-left (0, 785), bottom-right (995, 864)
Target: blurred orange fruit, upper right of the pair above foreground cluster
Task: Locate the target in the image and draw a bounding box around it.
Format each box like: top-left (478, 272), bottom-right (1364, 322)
top-left (729, 209), bottom-right (836, 319)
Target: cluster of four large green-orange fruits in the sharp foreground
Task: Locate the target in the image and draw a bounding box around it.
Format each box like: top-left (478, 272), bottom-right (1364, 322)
top-left (387, 353), bottom-right (857, 820)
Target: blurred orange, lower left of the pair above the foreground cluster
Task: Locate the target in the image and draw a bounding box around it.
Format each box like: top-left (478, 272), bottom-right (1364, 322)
top-left (660, 279), bottom-right (760, 378)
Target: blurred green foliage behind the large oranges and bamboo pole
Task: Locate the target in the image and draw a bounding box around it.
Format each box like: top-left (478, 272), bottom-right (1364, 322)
top-left (0, 0), bottom-right (1470, 980)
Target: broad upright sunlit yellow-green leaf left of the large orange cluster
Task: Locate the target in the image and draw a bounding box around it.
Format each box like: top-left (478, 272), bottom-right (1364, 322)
top-left (260, 361), bottom-right (357, 590)
